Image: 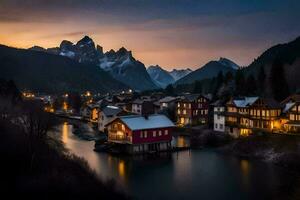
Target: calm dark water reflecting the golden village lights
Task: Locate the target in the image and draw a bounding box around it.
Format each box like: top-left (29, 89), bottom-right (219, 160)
top-left (49, 124), bottom-right (298, 200)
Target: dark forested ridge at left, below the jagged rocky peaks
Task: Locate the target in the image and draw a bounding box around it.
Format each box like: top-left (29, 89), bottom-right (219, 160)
top-left (0, 45), bottom-right (128, 93)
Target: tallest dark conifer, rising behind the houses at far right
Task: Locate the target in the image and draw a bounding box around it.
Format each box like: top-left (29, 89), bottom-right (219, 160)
top-left (270, 59), bottom-right (289, 101)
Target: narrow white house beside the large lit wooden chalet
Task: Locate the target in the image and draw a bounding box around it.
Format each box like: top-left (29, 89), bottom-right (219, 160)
top-left (211, 100), bottom-right (226, 132)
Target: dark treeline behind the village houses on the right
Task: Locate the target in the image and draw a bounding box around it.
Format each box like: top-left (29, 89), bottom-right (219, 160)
top-left (169, 56), bottom-right (297, 101)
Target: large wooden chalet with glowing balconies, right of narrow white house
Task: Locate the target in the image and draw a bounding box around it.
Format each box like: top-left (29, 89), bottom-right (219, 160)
top-left (225, 97), bottom-right (281, 137)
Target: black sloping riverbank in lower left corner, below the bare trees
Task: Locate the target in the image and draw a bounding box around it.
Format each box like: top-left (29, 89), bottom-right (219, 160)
top-left (0, 121), bottom-right (128, 199)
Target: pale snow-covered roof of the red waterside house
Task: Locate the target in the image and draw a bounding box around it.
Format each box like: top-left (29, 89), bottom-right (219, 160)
top-left (119, 115), bottom-right (174, 131)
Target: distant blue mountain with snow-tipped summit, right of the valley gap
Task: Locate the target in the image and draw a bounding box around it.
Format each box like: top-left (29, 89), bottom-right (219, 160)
top-left (175, 58), bottom-right (238, 85)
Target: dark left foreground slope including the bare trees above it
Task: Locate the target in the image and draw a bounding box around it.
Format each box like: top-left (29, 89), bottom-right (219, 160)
top-left (0, 80), bottom-right (127, 199)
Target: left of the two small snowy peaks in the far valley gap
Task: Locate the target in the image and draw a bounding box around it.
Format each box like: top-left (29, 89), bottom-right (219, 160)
top-left (147, 65), bottom-right (175, 88)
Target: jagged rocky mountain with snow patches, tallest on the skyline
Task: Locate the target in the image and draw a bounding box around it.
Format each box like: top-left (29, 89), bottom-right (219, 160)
top-left (31, 36), bottom-right (157, 90)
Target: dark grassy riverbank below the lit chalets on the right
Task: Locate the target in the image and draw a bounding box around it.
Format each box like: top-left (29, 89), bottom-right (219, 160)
top-left (219, 134), bottom-right (300, 171)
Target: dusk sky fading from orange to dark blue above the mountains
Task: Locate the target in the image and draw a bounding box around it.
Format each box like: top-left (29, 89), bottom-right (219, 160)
top-left (0, 0), bottom-right (300, 69)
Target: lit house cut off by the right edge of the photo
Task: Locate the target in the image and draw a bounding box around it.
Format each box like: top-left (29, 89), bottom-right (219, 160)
top-left (281, 95), bottom-right (300, 134)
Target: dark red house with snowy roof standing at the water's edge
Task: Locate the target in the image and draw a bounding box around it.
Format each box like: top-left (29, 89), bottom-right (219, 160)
top-left (107, 114), bottom-right (174, 153)
